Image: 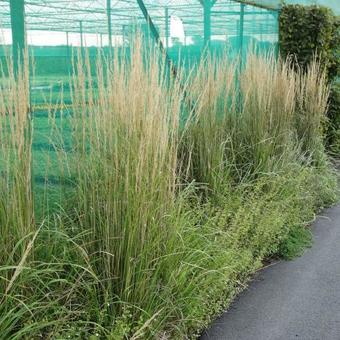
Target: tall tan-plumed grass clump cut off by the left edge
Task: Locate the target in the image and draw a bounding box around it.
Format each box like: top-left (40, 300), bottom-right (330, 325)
top-left (0, 58), bottom-right (35, 265)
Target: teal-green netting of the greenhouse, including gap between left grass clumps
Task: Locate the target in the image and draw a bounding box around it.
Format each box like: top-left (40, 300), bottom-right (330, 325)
top-left (0, 0), bottom-right (337, 209)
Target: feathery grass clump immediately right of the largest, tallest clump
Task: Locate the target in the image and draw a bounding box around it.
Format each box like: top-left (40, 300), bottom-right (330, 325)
top-left (180, 56), bottom-right (238, 190)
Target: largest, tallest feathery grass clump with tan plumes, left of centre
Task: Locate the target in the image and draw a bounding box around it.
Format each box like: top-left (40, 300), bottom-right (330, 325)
top-left (68, 42), bottom-right (182, 303)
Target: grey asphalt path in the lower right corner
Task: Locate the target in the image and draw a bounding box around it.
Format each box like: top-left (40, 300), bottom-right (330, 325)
top-left (201, 206), bottom-right (340, 340)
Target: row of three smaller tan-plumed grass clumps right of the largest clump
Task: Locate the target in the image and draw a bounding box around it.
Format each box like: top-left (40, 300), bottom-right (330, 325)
top-left (181, 54), bottom-right (328, 191)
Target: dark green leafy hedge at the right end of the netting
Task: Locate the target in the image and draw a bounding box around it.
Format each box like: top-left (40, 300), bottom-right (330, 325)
top-left (280, 5), bottom-right (340, 153)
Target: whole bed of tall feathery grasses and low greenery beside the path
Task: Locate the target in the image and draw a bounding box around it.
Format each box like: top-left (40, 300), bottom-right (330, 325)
top-left (0, 41), bottom-right (337, 339)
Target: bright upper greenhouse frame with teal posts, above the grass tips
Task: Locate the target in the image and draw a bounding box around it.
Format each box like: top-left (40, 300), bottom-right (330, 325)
top-left (0, 0), bottom-right (280, 69)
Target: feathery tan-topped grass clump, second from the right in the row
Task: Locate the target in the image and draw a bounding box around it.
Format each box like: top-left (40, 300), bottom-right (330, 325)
top-left (234, 54), bottom-right (298, 175)
